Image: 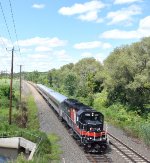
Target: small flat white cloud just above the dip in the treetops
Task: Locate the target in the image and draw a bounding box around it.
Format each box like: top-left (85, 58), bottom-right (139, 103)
top-left (74, 41), bottom-right (112, 49)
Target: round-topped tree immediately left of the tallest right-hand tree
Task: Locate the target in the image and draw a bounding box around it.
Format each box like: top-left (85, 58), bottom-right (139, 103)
top-left (73, 58), bottom-right (103, 97)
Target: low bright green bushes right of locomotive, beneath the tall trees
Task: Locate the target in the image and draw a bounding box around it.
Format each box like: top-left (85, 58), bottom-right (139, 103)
top-left (94, 91), bottom-right (150, 145)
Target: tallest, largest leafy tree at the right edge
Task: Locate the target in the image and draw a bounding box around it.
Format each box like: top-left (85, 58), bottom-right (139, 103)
top-left (104, 38), bottom-right (150, 114)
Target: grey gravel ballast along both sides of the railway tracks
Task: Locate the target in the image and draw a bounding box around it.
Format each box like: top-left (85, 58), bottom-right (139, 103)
top-left (23, 83), bottom-right (150, 163)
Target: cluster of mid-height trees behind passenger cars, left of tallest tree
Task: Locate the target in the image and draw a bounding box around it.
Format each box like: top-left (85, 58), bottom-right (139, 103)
top-left (47, 58), bottom-right (103, 100)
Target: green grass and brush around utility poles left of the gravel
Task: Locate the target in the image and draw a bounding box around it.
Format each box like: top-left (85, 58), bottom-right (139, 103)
top-left (0, 80), bottom-right (61, 163)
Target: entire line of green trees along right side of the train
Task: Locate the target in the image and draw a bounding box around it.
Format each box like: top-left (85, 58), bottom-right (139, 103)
top-left (24, 37), bottom-right (150, 115)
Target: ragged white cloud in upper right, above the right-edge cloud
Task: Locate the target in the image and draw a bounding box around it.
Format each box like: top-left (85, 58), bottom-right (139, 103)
top-left (106, 5), bottom-right (141, 25)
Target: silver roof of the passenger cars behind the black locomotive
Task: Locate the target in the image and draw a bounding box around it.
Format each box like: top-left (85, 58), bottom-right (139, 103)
top-left (37, 84), bottom-right (67, 103)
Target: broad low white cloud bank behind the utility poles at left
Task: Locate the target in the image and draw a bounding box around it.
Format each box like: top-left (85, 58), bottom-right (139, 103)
top-left (0, 37), bottom-right (71, 72)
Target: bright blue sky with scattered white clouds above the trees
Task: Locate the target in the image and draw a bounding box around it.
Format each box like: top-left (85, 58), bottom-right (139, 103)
top-left (0, 0), bottom-right (150, 72)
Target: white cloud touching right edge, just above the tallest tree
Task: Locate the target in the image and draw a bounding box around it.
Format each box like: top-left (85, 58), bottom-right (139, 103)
top-left (100, 16), bottom-right (150, 39)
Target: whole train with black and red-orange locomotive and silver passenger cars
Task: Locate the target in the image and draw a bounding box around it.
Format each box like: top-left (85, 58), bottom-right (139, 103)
top-left (37, 84), bottom-right (108, 153)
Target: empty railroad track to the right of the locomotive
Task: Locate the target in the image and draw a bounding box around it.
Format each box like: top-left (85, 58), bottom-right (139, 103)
top-left (108, 133), bottom-right (150, 163)
